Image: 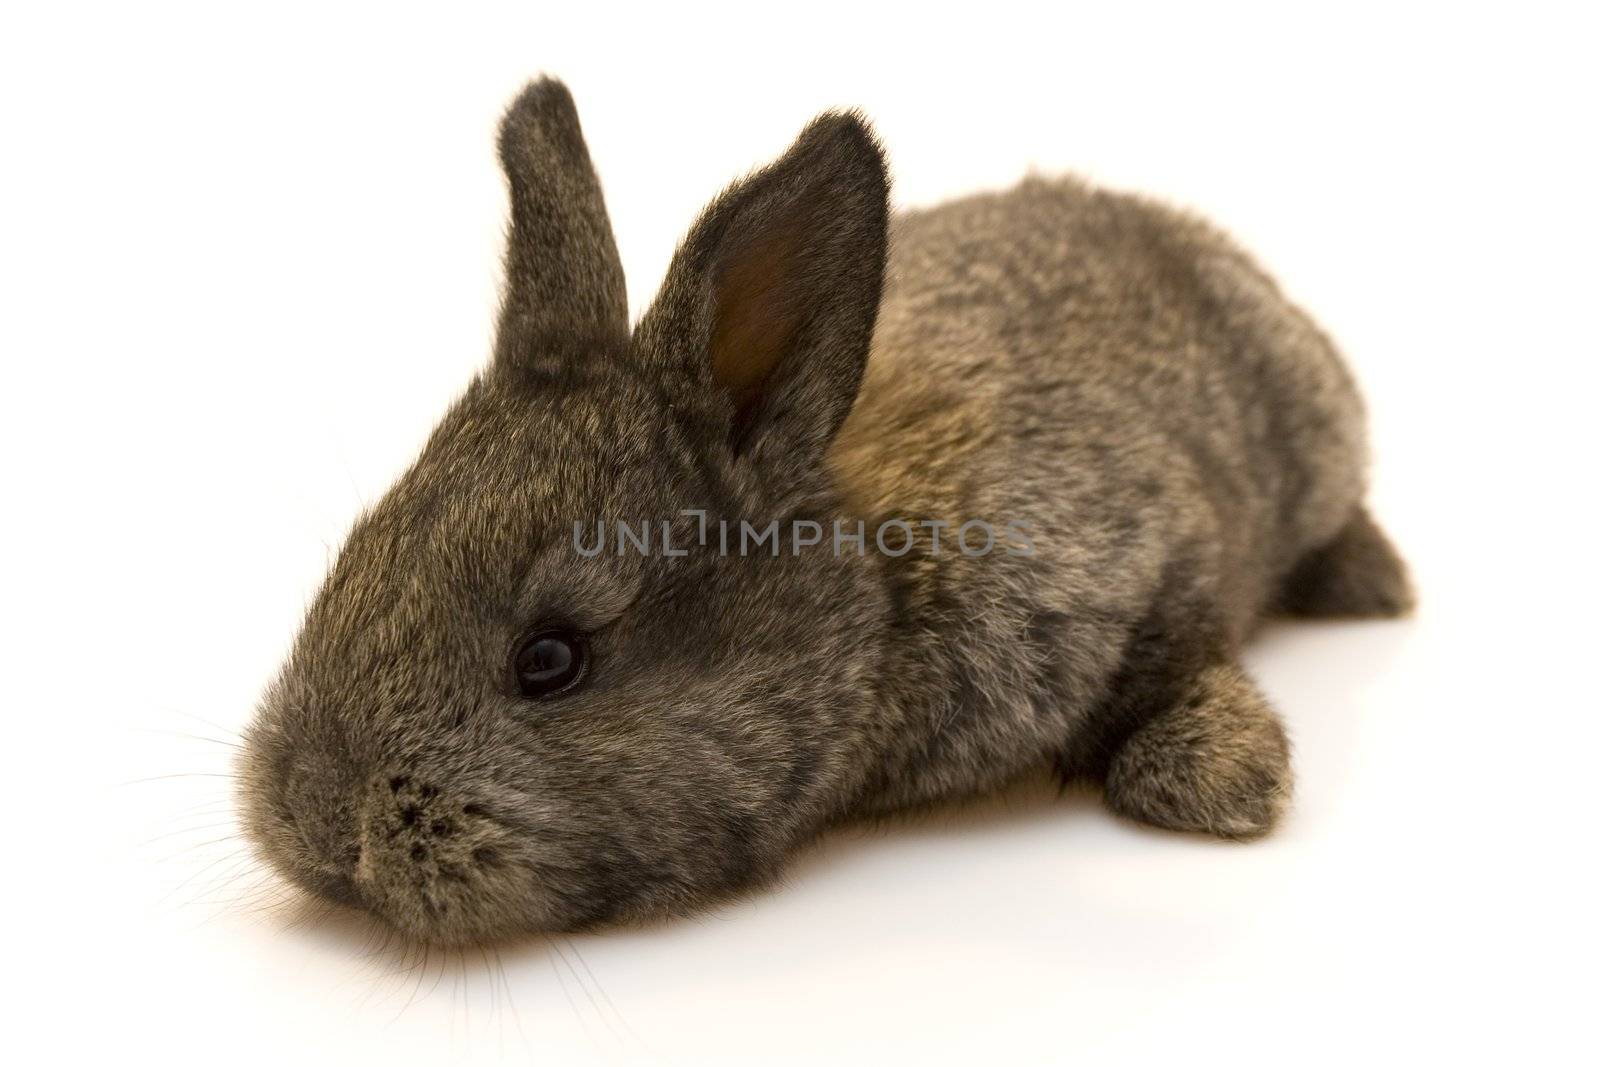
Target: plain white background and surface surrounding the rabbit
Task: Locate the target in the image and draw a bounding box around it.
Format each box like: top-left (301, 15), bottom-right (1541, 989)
top-left (0, 2), bottom-right (1600, 1065)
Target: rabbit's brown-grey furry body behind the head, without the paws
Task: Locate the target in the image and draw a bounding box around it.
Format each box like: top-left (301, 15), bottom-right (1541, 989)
top-left (832, 179), bottom-right (1366, 806)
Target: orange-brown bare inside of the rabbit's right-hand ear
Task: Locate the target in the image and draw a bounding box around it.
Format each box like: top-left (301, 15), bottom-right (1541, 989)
top-left (710, 218), bottom-right (803, 440)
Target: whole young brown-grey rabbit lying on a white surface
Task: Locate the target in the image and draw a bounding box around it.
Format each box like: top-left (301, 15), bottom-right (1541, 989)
top-left (238, 78), bottom-right (1413, 944)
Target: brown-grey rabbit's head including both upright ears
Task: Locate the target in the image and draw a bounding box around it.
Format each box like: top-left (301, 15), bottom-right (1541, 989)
top-left (240, 80), bottom-right (886, 942)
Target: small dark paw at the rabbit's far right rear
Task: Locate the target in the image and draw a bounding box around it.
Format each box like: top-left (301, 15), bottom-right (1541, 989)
top-left (1278, 507), bottom-right (1416, 617)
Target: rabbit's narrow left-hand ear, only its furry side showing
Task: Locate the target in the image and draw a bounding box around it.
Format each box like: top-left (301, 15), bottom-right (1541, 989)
top-left (494, 78), bottom-right (627, 365)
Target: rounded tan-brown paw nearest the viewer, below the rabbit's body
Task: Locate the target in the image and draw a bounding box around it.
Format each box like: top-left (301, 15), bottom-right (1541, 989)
top-left (1106, 662), bottom-right (1293, 840)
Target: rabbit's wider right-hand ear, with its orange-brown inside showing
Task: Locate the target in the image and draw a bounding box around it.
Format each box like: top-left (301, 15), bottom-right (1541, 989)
top-left (634, 114), bottom-right (888, 477)
